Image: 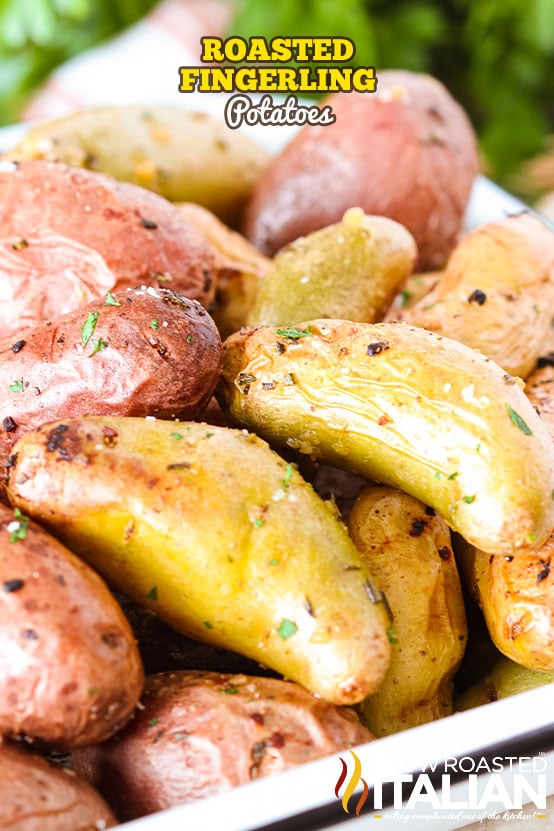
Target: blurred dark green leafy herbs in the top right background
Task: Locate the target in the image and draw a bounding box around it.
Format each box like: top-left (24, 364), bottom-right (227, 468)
top-left (232, 0), bottom-right (554, 186)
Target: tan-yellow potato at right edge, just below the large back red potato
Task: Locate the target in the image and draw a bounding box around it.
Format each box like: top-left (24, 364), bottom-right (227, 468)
top-left (386, 214), bottom-right (554, 378)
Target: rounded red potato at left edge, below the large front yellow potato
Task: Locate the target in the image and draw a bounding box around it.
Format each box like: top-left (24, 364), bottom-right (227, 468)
top-left (0, 504), bottom-right (143, 749)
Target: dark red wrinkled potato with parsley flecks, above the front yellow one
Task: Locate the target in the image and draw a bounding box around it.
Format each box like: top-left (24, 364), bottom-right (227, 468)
top-left (0, 287), bottom-right (221, 488)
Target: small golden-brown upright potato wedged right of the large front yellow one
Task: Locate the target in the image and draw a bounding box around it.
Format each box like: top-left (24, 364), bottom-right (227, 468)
top-left (348, 486), bottom-right (467, 736)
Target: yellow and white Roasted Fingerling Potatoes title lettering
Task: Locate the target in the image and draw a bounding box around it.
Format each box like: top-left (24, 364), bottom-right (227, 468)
top-left (179, 37), bottom-right (377, 130)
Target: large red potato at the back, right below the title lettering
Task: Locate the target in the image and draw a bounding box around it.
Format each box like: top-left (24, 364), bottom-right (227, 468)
top-left (244, 70), bottom-right (478, 269)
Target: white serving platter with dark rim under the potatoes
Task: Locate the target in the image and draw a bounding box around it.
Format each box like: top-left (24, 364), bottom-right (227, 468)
top-left (0, 112), bottom-right (554, 831)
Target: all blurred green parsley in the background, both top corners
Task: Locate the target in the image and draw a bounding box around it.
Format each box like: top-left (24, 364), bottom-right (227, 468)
top-left (0, 0), bottom-right (554, 193)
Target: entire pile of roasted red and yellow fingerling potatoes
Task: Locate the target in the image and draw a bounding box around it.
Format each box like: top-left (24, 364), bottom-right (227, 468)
top-left (0, 71), bottom-right (554, 831)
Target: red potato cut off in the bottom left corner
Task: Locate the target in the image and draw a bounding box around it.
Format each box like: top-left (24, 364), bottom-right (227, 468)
top-left (0, 742), bottom-right (118, 831)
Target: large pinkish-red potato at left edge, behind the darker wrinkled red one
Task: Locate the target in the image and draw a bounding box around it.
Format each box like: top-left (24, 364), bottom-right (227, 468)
top-left (0, 161), bottom-right (217, 335)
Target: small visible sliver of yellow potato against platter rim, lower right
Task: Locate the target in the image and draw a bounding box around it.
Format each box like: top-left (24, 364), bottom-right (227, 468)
top-left (456, 656), bottom-right (554, 710)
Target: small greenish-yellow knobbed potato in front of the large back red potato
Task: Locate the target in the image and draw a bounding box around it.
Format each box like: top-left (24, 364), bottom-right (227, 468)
top-left (248, 208), bottom-right (417, 326)
